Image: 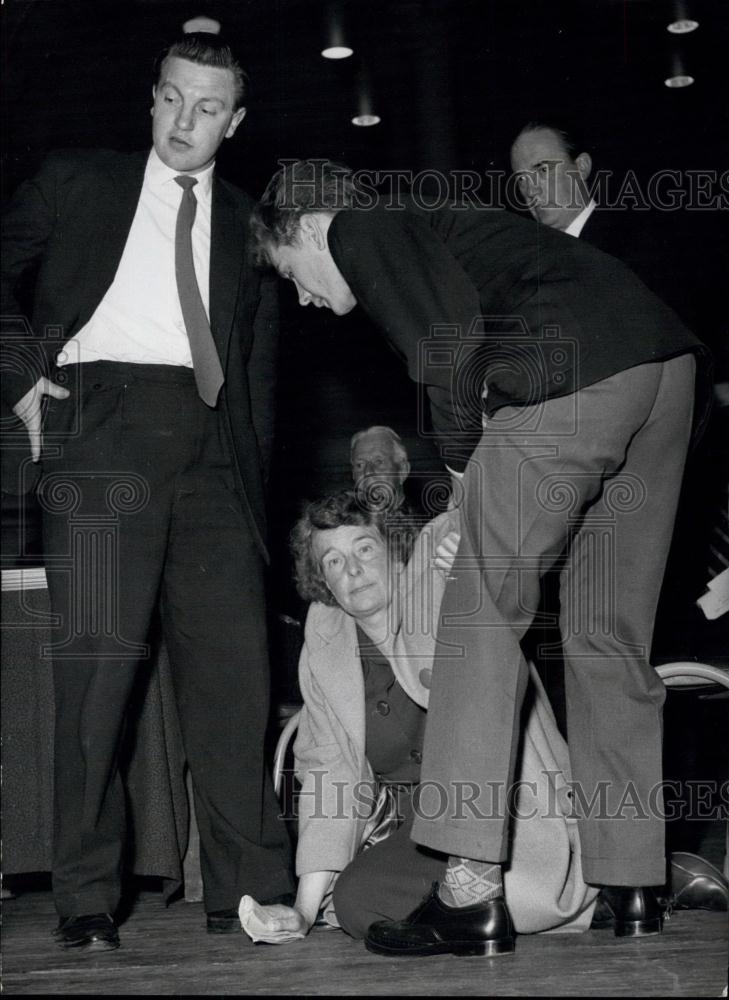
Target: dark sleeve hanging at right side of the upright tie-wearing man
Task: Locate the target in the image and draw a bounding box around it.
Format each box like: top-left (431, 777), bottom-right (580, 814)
top-left (248, 276), bottom-right (279, 481)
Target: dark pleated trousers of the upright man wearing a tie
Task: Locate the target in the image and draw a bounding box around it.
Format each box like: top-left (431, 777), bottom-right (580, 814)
top-left (39, 362), bottom-right (290, 917)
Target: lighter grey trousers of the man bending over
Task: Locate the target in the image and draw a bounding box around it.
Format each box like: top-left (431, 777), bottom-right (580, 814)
top-left (413, 354), bottom-right (695, 885)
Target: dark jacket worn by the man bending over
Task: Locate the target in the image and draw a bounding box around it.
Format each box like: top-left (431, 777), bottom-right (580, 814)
top-left (328, 205), bottom-right (707, 468)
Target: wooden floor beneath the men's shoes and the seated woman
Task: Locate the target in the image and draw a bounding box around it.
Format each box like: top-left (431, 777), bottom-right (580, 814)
top-left (3, 891), bottom-right (728, 997)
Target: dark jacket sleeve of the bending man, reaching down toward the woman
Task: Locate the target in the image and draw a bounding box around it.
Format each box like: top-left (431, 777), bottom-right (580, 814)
top-left (329, 208), bottom-right (481, 470)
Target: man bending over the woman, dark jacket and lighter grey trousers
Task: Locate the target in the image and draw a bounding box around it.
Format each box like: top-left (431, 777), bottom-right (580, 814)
top-left (253, 161), bottom-right (702, 955)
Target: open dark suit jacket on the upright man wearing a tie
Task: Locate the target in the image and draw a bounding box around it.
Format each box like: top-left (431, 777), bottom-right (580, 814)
top-left (2, 150), bottom-right (278, 554)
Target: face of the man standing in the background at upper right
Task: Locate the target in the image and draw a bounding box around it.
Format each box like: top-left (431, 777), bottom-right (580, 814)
top-left (511, 128), bottom-right (591, 229)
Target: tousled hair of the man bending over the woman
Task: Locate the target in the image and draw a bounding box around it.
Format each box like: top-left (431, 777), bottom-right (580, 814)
top-left (251, 160), bottom-right (356, 265)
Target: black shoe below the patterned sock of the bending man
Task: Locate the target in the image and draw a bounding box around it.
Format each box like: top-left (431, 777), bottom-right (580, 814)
top-left (365, 882), bottom-right (514, 957)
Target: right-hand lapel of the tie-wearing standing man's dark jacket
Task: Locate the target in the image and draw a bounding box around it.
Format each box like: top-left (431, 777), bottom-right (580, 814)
top-left (210, 177), bottom-right (248, 368)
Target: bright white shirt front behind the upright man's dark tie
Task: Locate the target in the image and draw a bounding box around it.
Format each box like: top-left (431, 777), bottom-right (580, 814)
top-left (57, 149), bottom-right (214, 368)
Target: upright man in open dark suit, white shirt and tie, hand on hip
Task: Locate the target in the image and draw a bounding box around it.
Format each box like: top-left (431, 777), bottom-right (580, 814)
top-left (3, 32), bottom-right (291, 951)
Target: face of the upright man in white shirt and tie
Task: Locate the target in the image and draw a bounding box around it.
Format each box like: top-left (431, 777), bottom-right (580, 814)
top-left (152, 56), bottom-right (245, 174)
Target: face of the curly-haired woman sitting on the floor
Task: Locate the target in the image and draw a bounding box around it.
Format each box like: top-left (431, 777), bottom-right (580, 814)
top-left (312, 524), bottom-right (393, 618)
